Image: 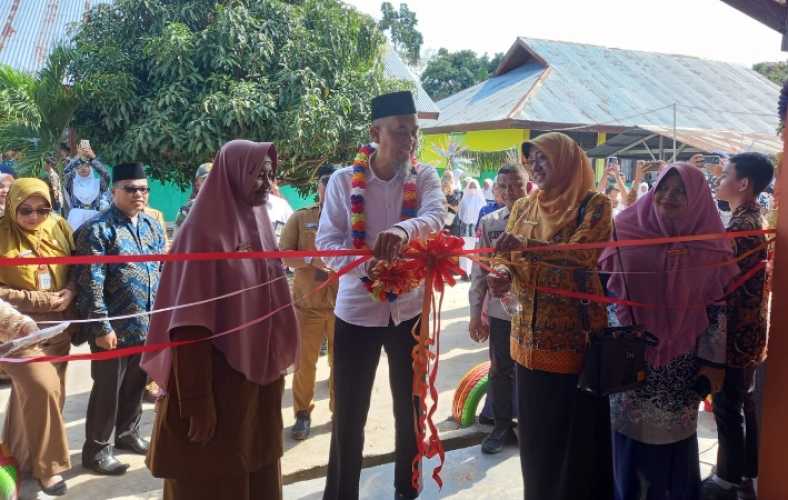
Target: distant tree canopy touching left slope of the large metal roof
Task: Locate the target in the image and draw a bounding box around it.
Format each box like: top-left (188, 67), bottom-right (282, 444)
top-left (421, 49), bottom-right (503, 101)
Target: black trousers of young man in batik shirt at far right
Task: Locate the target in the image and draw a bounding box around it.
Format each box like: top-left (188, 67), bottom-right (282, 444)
top-left (714, 366), bottom-right (758, 484)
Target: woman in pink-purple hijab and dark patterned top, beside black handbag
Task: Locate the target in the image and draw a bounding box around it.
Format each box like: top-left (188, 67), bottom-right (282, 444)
top-left (600, 163), bottom-right (739, 500)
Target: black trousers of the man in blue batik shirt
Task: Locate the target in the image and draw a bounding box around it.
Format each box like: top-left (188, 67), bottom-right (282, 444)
top-left (82, 354), bottom-right (148, 463)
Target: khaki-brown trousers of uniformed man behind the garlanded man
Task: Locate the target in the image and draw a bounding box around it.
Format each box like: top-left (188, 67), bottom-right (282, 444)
top-left (293, 308), bottom-right (334, 415)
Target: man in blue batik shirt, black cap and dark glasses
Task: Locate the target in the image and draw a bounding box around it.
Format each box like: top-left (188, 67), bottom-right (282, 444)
top-left (76, 163), bottom-right (164, 475)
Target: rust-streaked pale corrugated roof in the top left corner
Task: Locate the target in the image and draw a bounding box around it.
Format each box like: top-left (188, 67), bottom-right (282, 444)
top-left (0, 0), bottom-right (111, 73)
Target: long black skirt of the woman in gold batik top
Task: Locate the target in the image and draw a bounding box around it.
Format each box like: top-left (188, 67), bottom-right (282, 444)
top-left (517, 364), bottom-right (613, 500)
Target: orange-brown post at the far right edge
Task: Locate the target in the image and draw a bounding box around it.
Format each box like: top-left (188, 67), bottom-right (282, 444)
top-left (758, 123), bottom-right (788, 500)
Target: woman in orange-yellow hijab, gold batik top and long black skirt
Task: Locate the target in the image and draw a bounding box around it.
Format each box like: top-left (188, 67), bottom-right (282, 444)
top-left (488, 132), bottom-right (613, 500)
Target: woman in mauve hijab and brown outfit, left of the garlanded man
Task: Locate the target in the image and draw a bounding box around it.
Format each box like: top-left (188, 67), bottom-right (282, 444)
top-left (142, 140), bottom-right (299, 500)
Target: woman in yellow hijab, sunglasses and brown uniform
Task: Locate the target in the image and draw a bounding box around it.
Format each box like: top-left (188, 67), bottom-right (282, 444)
top-left (0, 178), bottom-right (76, 496)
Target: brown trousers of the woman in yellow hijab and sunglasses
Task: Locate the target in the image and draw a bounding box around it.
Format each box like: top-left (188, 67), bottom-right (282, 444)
top-left (2, 336), bottom-right (71, 479)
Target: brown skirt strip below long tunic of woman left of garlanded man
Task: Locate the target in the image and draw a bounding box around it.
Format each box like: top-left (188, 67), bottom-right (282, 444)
top-left (164, 460), bottom-right (282, 500)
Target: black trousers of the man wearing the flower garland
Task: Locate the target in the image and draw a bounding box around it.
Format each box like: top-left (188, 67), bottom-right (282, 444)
top-left (323, 317), bottom-right (421, 500)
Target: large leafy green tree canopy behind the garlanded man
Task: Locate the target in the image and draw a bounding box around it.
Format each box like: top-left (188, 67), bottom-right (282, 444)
top-left (70, 0), bottom-right (407, 190)
